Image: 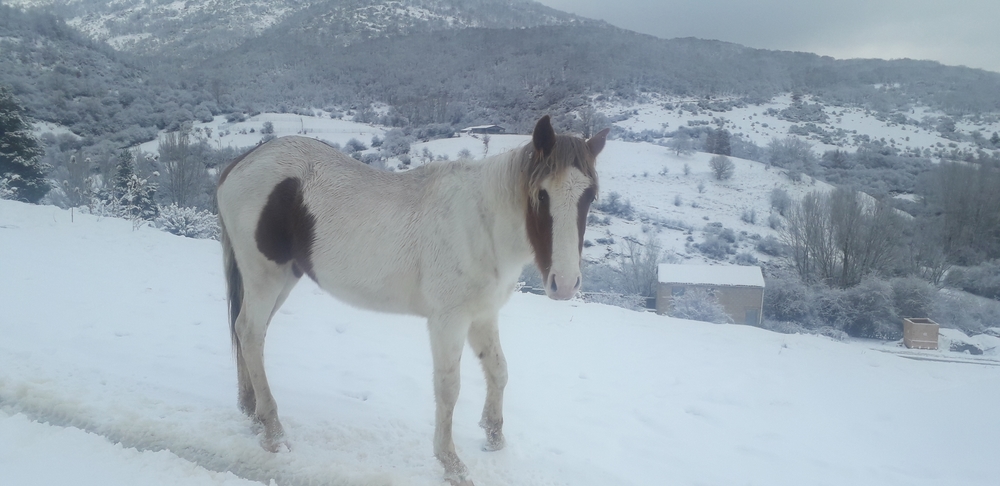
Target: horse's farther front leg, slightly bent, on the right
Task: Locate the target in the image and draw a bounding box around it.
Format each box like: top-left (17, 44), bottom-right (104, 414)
top-left (469, 316), bottom-right (507, 451)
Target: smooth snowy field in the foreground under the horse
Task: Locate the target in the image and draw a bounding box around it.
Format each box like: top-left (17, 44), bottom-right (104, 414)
top-left (0, 201), bottom-right (1000, 486)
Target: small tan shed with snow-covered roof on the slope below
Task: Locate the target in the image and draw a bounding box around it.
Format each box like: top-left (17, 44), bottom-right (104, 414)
top-left (656, 263), bottom-right (764, 325)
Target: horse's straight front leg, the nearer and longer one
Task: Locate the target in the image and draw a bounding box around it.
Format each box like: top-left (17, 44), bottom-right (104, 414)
top-left (427, 317), bottom-right (472, 486)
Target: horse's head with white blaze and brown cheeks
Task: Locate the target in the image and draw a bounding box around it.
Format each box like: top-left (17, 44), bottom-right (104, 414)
top-left (526, 115), bottom-right (609, 300)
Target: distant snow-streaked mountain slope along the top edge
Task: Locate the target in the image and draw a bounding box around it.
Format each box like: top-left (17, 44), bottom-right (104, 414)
top-left (9, 0), bottom-right (585, 55)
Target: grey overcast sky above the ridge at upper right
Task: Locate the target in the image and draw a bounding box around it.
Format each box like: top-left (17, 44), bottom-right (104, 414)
top-left (538, 0), bottom-right (1000, 72)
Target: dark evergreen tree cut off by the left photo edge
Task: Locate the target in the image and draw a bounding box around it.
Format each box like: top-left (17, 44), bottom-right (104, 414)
top-left (0, 86), bottom-right (50, 203)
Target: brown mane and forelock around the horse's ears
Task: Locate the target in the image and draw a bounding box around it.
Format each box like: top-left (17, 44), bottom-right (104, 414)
top-left (517, 135), bottom-right (597, 208)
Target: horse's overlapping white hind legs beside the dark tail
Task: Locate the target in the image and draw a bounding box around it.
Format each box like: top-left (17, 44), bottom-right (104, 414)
top-left (235, 265), bottom-right (298, 452)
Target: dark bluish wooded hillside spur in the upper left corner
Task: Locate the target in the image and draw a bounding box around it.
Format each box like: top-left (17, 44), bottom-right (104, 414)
top-left (0, 5), bottom-right (224, 141)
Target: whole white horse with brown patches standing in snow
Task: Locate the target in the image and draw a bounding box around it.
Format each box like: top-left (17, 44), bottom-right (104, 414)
top-left (218, 116), bottom-right (608, 484)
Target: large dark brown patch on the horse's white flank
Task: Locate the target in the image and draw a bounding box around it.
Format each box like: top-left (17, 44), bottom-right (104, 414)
top-left (254, 177), bottom-right (316, 280)
